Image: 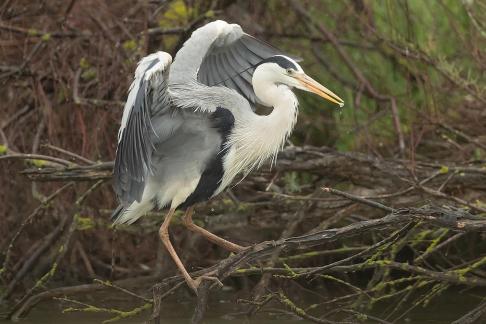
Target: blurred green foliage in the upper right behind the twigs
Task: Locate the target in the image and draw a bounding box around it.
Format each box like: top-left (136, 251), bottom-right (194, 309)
top-left (282, 0), bottom-right (486, 150)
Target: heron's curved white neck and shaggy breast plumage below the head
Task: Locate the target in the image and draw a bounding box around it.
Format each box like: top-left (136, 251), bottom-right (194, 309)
top-left (222, 76), bottom-right (298, 187)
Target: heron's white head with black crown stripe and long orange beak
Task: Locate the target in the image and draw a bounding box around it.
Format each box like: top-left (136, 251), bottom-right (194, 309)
top-left (253, 55), bottom-right (344, 107)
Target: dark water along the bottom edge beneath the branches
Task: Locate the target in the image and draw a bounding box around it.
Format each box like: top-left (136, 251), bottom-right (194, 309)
top-left (0, 292), bottom-right (486, 324)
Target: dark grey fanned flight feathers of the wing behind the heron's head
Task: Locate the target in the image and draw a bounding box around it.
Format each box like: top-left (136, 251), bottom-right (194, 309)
top-left (197, 33), bottom-right (290, 104)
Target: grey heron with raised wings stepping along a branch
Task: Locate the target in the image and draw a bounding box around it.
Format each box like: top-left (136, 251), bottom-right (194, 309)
top-left (112, 20), bottom-right (344, 294)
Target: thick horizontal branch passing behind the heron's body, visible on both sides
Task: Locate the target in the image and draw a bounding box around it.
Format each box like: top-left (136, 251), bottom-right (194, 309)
top-left (15, 146), bottom-right (486, 190)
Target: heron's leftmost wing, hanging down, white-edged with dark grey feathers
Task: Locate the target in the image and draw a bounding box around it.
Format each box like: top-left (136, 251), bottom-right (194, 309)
top-left (114, 52), bottom-right (172, 206)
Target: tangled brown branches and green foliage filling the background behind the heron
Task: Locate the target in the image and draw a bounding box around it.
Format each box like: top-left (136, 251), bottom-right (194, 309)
top-left (0, 0), bottom-right (486, 323)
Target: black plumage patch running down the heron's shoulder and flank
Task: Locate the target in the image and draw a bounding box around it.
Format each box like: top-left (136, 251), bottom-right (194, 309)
top-left (179, 107), bottom-right (235, 208)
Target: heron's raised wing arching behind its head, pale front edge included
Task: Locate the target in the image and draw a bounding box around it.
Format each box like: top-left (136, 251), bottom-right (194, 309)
top-left (169, 20), bottom-right (300, 111)
